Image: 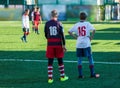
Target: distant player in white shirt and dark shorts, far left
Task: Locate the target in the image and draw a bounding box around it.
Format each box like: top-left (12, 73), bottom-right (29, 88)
top-left (21, 9), bottom-right (30, 42)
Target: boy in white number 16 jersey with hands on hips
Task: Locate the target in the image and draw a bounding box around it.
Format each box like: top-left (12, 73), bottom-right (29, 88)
top-left (68, 12), bottom-right (100, 78)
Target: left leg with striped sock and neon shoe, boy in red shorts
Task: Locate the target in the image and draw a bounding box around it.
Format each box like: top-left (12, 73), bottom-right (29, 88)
top-left (48, 58), bottom-right (54, 83)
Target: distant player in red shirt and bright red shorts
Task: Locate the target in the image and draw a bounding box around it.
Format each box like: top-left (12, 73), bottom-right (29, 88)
top-left (34, 7), bottom-right (42, 34)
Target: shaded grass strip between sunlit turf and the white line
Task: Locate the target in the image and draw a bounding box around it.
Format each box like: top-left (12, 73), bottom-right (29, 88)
top-left (0, 50), bottom-right (120, 62)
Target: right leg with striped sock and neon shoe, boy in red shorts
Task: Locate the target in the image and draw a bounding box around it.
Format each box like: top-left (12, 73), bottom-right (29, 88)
top-left (58, 58), bottom-right (68, 81)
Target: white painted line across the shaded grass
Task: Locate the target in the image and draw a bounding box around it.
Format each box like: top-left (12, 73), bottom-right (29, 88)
top-left (0, 59), bottom-right (120, 65)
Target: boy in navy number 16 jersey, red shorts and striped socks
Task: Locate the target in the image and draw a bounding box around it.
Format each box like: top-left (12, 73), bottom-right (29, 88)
top-left (44, 10), bottom-right (68, 83)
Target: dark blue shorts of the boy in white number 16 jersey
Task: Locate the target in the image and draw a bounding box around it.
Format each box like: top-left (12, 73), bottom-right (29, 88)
top-left (76, 47), bottom-right (92, 57)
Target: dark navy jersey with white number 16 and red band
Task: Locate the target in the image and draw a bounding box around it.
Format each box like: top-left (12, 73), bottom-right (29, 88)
top-left (45, 20), bottom-right (65, 46)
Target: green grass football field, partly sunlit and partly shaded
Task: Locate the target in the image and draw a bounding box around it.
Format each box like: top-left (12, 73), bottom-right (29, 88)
top-left (0, 21), bottom-right (120, 88)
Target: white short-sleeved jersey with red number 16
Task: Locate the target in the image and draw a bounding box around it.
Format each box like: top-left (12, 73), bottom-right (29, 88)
top-left (69, 21), bottom-right (95, 48)
